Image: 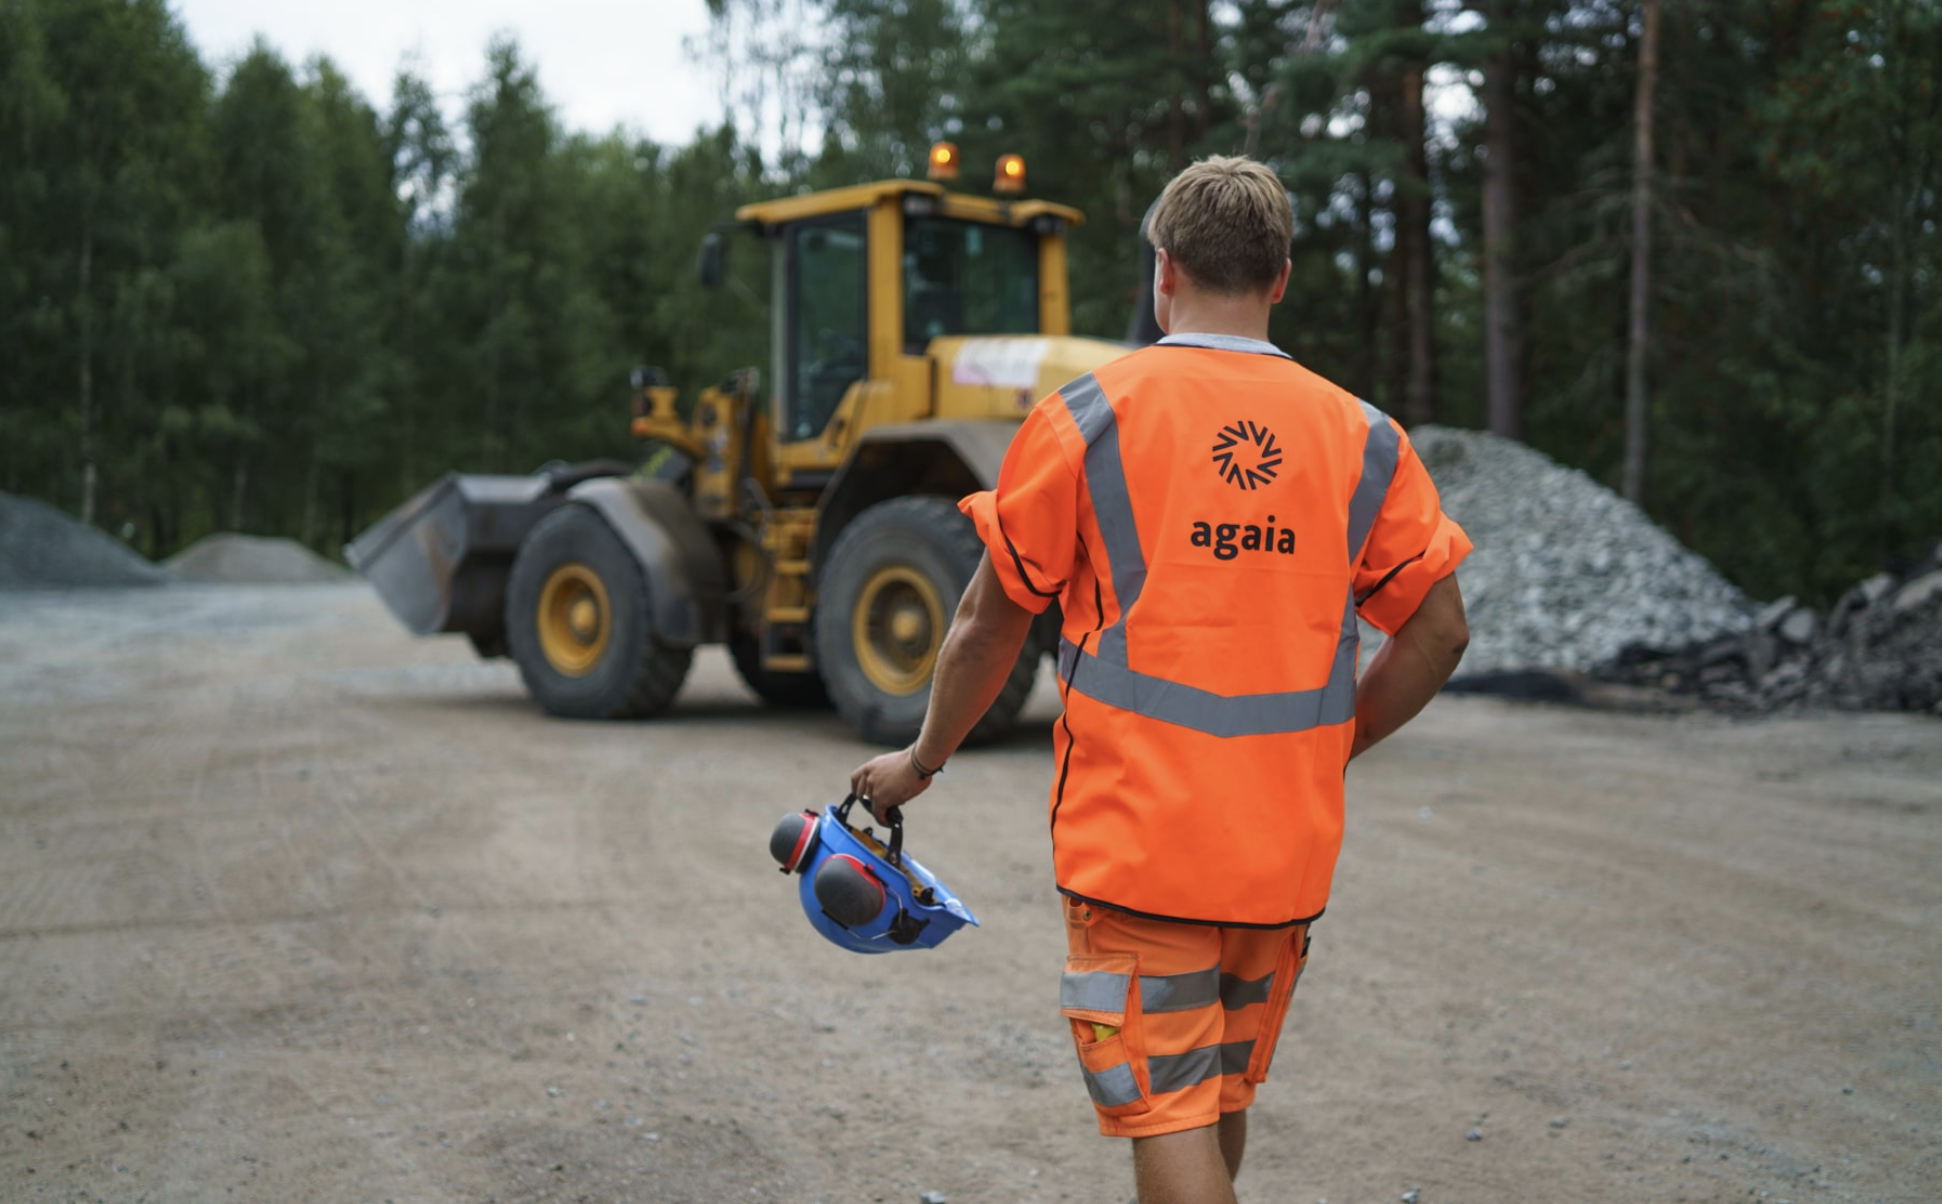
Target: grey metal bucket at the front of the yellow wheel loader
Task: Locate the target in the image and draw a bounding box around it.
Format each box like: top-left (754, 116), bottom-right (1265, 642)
top-left (344, 472), bottom-right (565, 645)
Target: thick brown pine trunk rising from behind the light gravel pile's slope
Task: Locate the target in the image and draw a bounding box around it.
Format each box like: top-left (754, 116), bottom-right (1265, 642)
top-left (1484, 0), bottom-right (1524, 439)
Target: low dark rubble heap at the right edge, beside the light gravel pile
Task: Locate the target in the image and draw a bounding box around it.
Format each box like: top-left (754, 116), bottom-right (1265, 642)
top-left (1598, 544), bottom-right (1942, 715)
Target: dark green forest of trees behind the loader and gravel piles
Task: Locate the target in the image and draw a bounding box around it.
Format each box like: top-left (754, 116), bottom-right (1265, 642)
top-left (0, 0), bottom-right (1942, 602)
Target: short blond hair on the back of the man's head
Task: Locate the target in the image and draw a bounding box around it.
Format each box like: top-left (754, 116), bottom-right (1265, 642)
top-left (1146, 155), bottom-right (1295, 295)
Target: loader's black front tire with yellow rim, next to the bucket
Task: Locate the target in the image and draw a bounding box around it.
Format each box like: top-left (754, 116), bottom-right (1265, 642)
top-left (505, 505), bottom-right (693, 719)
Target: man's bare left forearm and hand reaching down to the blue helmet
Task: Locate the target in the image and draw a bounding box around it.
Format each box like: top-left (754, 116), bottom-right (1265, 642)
top-left (851, 553), bottom-right (1035, 819)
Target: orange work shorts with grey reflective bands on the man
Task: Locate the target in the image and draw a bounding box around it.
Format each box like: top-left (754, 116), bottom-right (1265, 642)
top-left (1058, 897), bottom-right (1309, 1138)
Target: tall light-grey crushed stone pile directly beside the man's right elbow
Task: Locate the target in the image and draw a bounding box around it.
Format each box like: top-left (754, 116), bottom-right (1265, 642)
top-left (1410, 425), bottom-right (1756, 678)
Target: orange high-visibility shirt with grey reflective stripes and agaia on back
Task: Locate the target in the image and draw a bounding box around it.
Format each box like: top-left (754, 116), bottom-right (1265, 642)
top-left (961, 336), bottom-right (1470, 926)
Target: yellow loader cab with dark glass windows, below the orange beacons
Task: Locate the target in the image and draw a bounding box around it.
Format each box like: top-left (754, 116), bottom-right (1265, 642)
top-left (736, 181), bottom-right (1080, 491)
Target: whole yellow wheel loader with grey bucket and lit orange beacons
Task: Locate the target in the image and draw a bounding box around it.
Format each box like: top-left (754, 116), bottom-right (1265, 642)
top-left (344, 152), bottom-right (1126, 746)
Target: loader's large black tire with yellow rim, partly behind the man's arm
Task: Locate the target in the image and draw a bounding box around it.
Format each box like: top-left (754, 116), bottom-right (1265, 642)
top-left (816, 497), bottom-right (1039, 746)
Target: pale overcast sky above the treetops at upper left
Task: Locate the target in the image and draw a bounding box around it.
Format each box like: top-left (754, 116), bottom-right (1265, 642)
top-left (171, 0), bottom-right (720, 144)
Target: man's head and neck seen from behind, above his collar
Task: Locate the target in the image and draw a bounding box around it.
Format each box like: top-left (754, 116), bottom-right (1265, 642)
top-left (1146, 155), bottom-right (1295, 332)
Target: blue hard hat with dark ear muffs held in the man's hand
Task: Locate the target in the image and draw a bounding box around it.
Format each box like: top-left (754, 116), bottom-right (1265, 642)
top-left (769, 794), bottom-right (977, 953)
